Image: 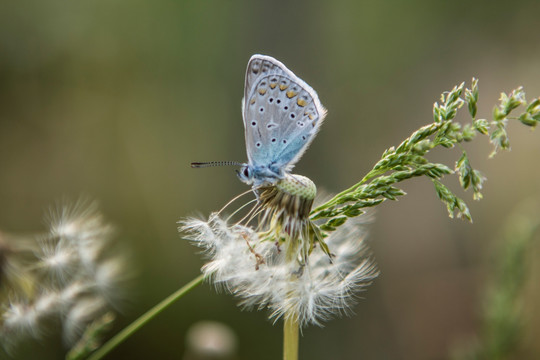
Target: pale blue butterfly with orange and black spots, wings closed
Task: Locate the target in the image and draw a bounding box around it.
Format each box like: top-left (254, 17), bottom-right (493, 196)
top-left (192, 55), bottom-right (326, 189)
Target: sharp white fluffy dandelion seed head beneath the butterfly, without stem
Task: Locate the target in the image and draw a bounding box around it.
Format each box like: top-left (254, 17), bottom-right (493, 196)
top-left (179, 175), bottom-right (378, 326)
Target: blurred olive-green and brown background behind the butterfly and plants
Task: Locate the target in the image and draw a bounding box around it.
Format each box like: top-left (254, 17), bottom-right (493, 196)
top-left (0, 0), bottom-right (540, 360)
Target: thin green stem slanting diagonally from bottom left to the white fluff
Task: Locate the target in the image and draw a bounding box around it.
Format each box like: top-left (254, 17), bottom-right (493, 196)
top-left (88, 274), bottom-right (204, 360)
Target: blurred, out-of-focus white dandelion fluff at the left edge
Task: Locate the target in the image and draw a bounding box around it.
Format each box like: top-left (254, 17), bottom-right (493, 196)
top-left (0, 202), bottom-right (126, 352)
